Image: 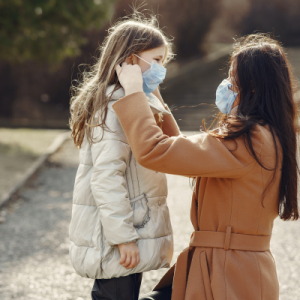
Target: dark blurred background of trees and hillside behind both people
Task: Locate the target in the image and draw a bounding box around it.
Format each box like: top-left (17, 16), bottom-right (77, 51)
top-left (0, 0), bottom-right (300, 130)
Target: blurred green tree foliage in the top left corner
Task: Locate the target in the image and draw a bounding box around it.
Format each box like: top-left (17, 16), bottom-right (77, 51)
top-left (0, 0), bottom-right (115, 63)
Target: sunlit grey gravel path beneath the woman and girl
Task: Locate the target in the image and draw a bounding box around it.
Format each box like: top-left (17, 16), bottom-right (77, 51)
top-left (0, 142), bottom-right (300, 300)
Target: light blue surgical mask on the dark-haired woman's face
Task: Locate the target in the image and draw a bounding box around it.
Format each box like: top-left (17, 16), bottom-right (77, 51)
top-left (216, 79), bottom-right (238, 114)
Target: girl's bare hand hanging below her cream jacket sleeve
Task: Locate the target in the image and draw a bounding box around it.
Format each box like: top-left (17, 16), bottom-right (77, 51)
top-left (118, 242), bottom-right (140, 269)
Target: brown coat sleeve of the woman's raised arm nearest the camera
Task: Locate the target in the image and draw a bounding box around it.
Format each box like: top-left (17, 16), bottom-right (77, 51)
top-left (113, 92), bottom-right (261, 178)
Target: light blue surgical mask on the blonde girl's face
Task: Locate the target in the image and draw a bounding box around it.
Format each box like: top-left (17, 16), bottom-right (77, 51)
top-left (134, 54), bottom-right (167, 95)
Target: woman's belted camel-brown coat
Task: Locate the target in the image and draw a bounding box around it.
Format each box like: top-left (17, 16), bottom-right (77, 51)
top-left (113, 92), bottom-right (281, 300)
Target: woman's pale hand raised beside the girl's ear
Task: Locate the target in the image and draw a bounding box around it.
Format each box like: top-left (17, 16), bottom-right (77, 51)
top-left (116, 62), bottom-right (143, 96)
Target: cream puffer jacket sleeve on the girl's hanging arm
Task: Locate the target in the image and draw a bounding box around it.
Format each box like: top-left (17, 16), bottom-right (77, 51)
top-left (91, 127), bottom-right (139, 245)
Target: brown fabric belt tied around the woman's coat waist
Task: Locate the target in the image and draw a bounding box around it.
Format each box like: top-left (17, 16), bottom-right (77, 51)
top-left (172, 226), bottom-right (271, 300)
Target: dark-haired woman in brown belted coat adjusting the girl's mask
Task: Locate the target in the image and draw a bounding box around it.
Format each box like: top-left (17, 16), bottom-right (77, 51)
top-left (113, 35), bottom-right (299, 300)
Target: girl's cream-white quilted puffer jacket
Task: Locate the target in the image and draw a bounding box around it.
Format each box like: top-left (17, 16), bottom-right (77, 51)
top-left (70, 86), bottom-right (173, 279)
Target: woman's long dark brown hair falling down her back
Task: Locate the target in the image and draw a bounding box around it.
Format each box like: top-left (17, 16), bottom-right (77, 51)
top-left (209, 34), bottom-right (299, 220)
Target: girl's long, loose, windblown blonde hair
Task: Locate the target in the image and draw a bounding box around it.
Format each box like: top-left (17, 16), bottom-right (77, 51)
top-left (69, 13), bottom-right (173, 148)
